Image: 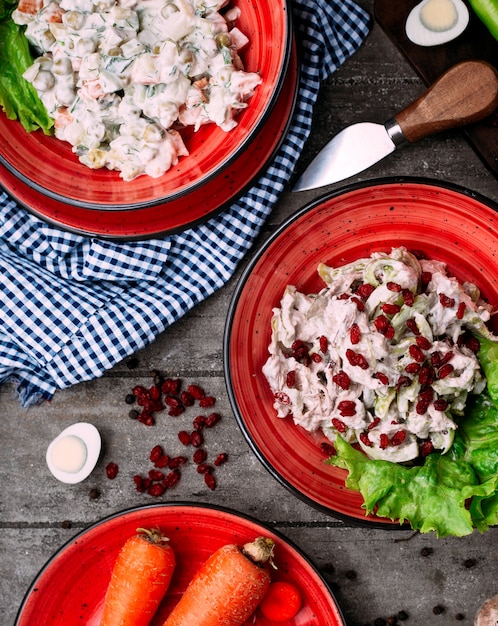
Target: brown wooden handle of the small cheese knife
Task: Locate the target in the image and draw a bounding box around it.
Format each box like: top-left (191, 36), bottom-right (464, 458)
top-left (394, 61), bottom-right (498, 142)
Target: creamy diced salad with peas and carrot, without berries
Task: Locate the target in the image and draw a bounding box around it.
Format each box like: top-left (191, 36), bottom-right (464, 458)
top-left (12, 0), bottom-right (262, 181)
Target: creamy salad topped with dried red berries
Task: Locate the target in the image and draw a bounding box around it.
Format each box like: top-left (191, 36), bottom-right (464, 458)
top-left (263, 247), bottom-right (498, 462)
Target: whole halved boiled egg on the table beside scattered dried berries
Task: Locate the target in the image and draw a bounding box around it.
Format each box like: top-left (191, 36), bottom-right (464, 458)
top-left (46, 422), bottom-right (102, 484)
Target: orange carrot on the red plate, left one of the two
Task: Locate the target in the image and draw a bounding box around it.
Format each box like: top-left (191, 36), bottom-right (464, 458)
top-left (100, 528), bottom-right (176, 626)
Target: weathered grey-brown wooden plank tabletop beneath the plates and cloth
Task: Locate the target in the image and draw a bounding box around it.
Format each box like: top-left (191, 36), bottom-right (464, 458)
top-left (0, 0), bottom-right (498, 626)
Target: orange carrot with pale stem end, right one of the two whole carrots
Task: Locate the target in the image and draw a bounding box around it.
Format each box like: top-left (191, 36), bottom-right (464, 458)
top-left (163, 537), bottom-right (275, 626)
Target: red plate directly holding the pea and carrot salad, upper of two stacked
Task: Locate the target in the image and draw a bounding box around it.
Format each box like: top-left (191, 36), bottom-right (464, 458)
top-left (0, 0), bottom-right (292, 210)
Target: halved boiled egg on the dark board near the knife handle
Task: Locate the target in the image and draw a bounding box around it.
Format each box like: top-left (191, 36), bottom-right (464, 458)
top-left (405, 0), bottom-right (470, 46)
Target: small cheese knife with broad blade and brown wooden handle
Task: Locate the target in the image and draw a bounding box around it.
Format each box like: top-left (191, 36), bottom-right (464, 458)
top-left (292, 61), bottom-right (498, 191)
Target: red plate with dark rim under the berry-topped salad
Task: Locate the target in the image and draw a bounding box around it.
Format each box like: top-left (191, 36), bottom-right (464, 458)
top-left (224, 179), bottom-right (498, 528)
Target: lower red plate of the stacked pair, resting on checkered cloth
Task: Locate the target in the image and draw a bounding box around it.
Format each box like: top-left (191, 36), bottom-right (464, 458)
top-left (0, 44), bottom-right (298, 239)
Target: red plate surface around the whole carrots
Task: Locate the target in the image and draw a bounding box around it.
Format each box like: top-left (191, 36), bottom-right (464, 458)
top-left (15, 503), bottom-right (345, 626)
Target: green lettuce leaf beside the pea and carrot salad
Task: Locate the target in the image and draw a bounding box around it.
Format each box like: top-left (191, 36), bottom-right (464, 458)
top-left (0, 5), bottom-right (53, 135)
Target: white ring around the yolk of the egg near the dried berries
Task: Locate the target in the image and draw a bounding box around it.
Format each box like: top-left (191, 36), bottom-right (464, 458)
top-left (46, 422), bottom-right (102, 485)
